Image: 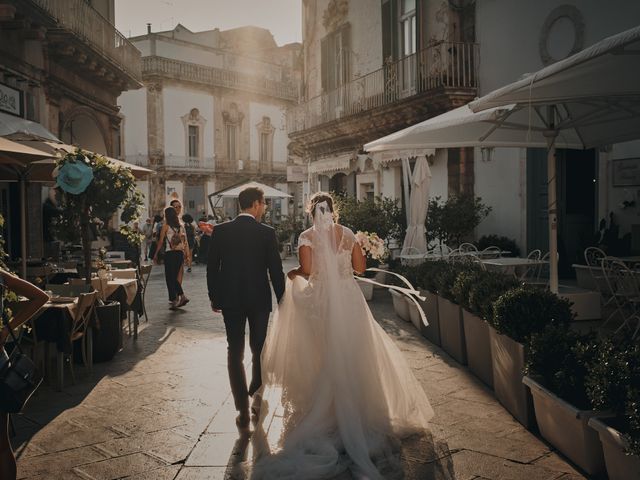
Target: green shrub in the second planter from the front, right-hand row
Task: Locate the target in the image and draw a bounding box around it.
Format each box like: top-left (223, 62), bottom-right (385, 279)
top-left (525, 324), bottom-right (598, 410)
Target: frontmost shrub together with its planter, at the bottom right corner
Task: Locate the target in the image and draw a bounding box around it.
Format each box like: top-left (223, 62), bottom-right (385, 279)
top-left (586, 339), bottom-right (640, 480)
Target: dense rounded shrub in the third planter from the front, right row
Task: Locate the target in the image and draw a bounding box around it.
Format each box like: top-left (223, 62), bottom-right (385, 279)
top-left (491, 285), bottom-right (573, 343)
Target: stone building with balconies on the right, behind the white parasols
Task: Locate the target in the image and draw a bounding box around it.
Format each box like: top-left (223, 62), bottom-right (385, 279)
top-left (288, 0), bottom-right (640, 269)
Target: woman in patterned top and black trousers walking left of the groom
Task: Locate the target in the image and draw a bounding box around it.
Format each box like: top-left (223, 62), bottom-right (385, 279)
top-left (153, 207), bottom-right (189, 310)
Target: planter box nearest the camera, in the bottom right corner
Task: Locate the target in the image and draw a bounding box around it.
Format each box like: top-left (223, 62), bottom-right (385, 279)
top-left (589, 418), bottom-right (640, 480)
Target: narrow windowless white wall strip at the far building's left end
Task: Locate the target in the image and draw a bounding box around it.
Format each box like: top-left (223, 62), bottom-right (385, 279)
top-left (118, 88), bottom-right (148, 157)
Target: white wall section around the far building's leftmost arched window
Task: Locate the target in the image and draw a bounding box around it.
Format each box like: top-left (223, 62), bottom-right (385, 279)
top-left (162, 86), bottom-right (214, 158)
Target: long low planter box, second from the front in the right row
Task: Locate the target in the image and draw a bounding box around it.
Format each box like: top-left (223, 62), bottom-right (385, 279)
top-left (522, 377), bottom-right (604, 476)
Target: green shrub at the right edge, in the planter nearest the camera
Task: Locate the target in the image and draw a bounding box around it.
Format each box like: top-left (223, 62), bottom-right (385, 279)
top-left (585, 339), bottom-right (640, 455)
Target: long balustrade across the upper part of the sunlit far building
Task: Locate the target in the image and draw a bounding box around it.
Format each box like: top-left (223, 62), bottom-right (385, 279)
top-left (142, 56), bottom-right (298, 102)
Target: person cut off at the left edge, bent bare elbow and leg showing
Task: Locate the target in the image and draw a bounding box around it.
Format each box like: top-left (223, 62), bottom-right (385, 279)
top-left (0, 270), bottom-right (49, 480)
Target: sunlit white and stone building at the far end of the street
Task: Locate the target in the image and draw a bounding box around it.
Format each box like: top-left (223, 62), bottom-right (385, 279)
top-left (119, 25), bottom-right (300, 218)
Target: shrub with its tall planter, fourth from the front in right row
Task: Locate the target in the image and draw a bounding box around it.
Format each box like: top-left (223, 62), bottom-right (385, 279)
top-left (453, 267), bottom-right (504, 387)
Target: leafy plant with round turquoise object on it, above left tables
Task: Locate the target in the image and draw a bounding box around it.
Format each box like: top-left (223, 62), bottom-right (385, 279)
top-left (53, 149), bottom-right (143, 282)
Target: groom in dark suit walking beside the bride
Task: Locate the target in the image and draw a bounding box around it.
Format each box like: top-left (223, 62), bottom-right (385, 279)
top-left (207, 187), bottom-right (284, 428)
